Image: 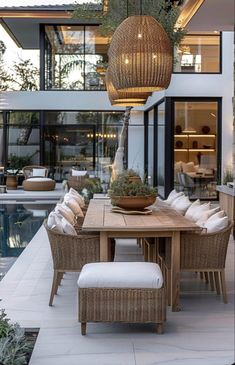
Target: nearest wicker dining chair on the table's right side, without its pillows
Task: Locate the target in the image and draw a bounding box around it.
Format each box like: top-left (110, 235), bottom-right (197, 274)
top-left (160, 222), bottom-right (233, 303)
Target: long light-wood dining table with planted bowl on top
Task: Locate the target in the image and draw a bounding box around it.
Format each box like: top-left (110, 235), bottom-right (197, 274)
top-left (82, 199), bottom-right (200, 311)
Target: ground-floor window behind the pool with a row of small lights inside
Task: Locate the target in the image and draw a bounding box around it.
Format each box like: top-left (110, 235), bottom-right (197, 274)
top-left (44, 111), bottom-right (123, 181)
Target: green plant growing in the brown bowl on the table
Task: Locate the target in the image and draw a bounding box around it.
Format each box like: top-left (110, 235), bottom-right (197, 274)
top-left (109, 170), bottom-right (157, 197)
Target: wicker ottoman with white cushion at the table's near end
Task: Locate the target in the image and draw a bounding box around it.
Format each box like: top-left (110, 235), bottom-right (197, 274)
top-left (78, 262), bottom-right (166, 335)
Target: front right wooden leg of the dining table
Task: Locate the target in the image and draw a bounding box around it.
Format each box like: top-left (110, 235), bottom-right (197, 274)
top-left (171, 232), bottom-right (180, 312)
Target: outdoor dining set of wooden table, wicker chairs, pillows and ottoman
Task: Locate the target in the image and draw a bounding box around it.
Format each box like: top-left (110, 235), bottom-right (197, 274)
top-left (44, 188), bottom-right (232, 335)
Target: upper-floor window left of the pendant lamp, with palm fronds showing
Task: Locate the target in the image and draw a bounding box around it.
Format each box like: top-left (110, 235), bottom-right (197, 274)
top-left (45, 25), bottom-right (108, 90)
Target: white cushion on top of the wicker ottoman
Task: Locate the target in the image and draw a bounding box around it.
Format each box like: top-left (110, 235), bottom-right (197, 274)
top-left (78, 262), bottom-right (163, 289)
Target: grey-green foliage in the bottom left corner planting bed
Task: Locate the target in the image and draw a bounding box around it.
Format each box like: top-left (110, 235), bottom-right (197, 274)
top-left (0, 310), bottom-right (33, 365)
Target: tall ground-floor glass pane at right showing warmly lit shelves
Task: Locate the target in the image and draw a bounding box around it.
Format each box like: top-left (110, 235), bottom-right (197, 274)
top-left (174, 100), bottom-right (219, 199)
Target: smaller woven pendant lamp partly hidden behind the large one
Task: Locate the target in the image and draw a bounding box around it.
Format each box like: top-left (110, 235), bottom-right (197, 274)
top-left (105, 68), bottom-right (151, 106)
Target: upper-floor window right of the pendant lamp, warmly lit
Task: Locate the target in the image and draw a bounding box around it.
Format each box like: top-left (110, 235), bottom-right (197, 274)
top-left (174, 33), bottom-right (221, 73)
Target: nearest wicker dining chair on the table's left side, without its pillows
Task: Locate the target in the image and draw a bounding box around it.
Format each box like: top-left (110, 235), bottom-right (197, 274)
top-left (44, 220), bottom-right (100, 306)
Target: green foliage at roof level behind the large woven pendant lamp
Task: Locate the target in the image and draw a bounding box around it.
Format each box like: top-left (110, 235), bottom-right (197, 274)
top-left (72, 0), bottom-right (186, 46)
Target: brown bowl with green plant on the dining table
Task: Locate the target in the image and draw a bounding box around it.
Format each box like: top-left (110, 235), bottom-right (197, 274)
top-left (109, 170), bottom-right (157, 210)
